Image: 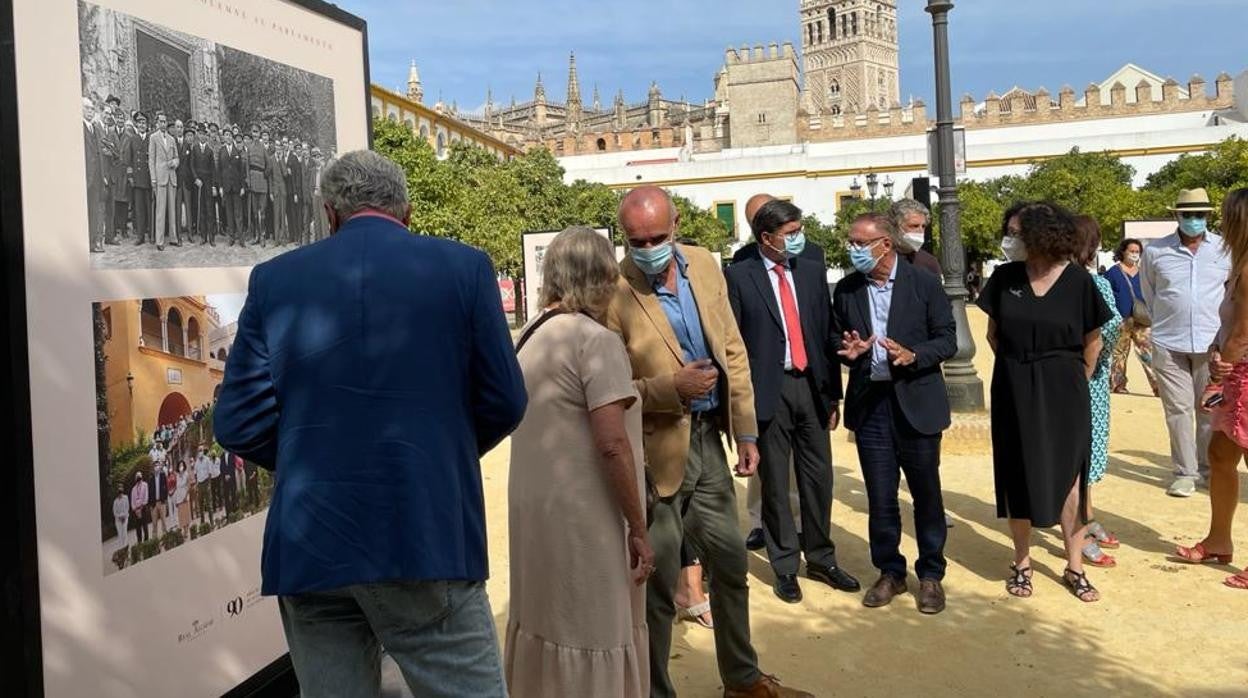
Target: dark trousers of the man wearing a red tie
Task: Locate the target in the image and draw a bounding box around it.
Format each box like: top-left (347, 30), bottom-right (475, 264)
top-left (759, 372), bottom-right (836, 574)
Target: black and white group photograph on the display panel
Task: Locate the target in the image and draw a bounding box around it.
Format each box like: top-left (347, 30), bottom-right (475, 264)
top-left (77, 1), bottom-right (337, 270)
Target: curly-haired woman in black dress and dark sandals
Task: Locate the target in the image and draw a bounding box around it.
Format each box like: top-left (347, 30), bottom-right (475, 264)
top-left (978, 204), bottom-right (1109, 602)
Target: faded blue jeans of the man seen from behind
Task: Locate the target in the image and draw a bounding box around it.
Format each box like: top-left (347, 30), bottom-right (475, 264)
top-left (278, 582), bottom-right (507, 698)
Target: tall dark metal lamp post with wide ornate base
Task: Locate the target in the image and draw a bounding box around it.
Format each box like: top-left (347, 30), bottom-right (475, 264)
top-left (927, 0), bottom-right (983, 412)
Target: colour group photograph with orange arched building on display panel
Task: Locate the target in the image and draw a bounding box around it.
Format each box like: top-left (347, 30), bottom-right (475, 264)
top-left (91, 293), bottom-right (273, 574)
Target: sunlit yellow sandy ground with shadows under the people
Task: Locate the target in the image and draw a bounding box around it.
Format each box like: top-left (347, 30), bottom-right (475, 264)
top-left (387, 311), bottom-right (1248, 697)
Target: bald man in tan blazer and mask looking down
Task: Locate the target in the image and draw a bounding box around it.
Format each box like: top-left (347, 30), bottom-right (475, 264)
top-left (607, 186), bottom-right (809, 698)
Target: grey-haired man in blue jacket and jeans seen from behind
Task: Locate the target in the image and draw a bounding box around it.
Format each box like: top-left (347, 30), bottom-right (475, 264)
top-left (215, 151), bottom-right (527, 697)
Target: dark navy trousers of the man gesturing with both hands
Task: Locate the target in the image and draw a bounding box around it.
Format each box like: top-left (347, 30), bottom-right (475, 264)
top-left (854, 383), bottom-right (948, 581)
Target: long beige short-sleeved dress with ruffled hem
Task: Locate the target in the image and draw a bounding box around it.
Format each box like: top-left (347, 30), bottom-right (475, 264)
top-left (504, 315), bottom-right (650, 698)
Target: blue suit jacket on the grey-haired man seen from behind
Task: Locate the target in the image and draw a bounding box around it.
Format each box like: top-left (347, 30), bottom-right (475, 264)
top-left (213, 216), bottom-right (527, 594)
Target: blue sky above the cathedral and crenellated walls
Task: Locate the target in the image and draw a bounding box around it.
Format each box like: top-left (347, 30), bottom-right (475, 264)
top-left (338, 0), bottom-right (1248, 110)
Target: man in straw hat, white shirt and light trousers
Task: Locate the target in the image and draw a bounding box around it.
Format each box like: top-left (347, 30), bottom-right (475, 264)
top-left (1139, 189), bottom-right (1231, 497)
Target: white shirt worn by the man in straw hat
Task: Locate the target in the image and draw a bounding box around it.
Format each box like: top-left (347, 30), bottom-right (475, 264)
top-left (1139, 232), bottom-right (1231, 353)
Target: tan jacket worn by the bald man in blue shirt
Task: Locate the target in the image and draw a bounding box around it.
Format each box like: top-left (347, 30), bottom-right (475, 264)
top-left (607, 245), bottom-right (759, 497)
